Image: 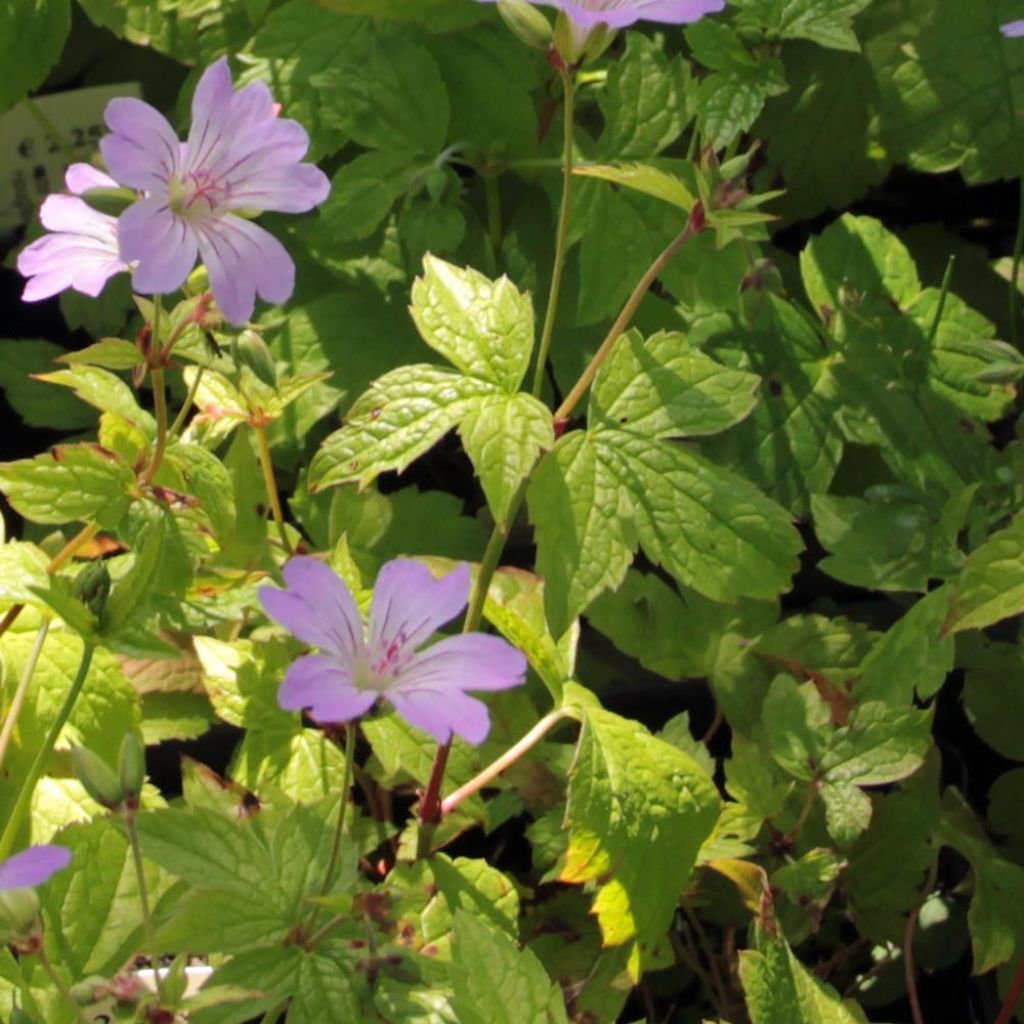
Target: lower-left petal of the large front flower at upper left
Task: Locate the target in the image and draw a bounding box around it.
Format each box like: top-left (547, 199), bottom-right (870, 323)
top-left (118, 196), bottom-right (198, 295)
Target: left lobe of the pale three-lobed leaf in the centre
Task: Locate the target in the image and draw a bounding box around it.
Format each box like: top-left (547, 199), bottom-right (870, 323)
top-left (307, 365), bottom-right (496, 490)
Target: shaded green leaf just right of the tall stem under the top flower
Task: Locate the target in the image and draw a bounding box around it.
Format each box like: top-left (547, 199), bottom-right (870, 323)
top-left (597, 32), bottom-right (694, 161)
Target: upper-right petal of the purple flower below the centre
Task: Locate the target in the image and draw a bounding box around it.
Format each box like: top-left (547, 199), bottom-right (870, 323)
top-left (370, 558), bottom-right (469, 663)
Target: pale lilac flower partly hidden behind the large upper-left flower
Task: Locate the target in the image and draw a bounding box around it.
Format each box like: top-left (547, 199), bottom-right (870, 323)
top-left (17, 164), bottom-right (128, 302)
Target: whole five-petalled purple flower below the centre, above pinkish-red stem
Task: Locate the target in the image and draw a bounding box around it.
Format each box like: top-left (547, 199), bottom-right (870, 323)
top-left (259, 558), bottom-right (526, 743)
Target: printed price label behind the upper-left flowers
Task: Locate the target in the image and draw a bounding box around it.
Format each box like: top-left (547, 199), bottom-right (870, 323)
top-left (0, 83), bottom-right (140, 234)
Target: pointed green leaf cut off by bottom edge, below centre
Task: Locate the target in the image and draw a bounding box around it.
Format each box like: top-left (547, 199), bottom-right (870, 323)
top-left (451, 909), bottom-right (568, 1024)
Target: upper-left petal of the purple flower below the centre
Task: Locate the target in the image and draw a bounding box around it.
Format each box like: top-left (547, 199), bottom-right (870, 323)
top-left (259, 556), bottom-right (366, 665)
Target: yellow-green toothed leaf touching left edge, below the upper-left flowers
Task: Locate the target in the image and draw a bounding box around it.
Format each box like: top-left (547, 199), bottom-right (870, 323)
top-left (0, 443), bottom-right (135, 529)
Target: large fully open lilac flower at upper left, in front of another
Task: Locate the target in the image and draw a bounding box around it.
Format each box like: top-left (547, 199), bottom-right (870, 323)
top-left (99, 57), bottom-right (331, 324)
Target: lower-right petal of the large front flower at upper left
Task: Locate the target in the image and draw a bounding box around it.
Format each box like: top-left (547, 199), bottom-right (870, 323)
top-left (195, 214), bottom-right (295, 325)
